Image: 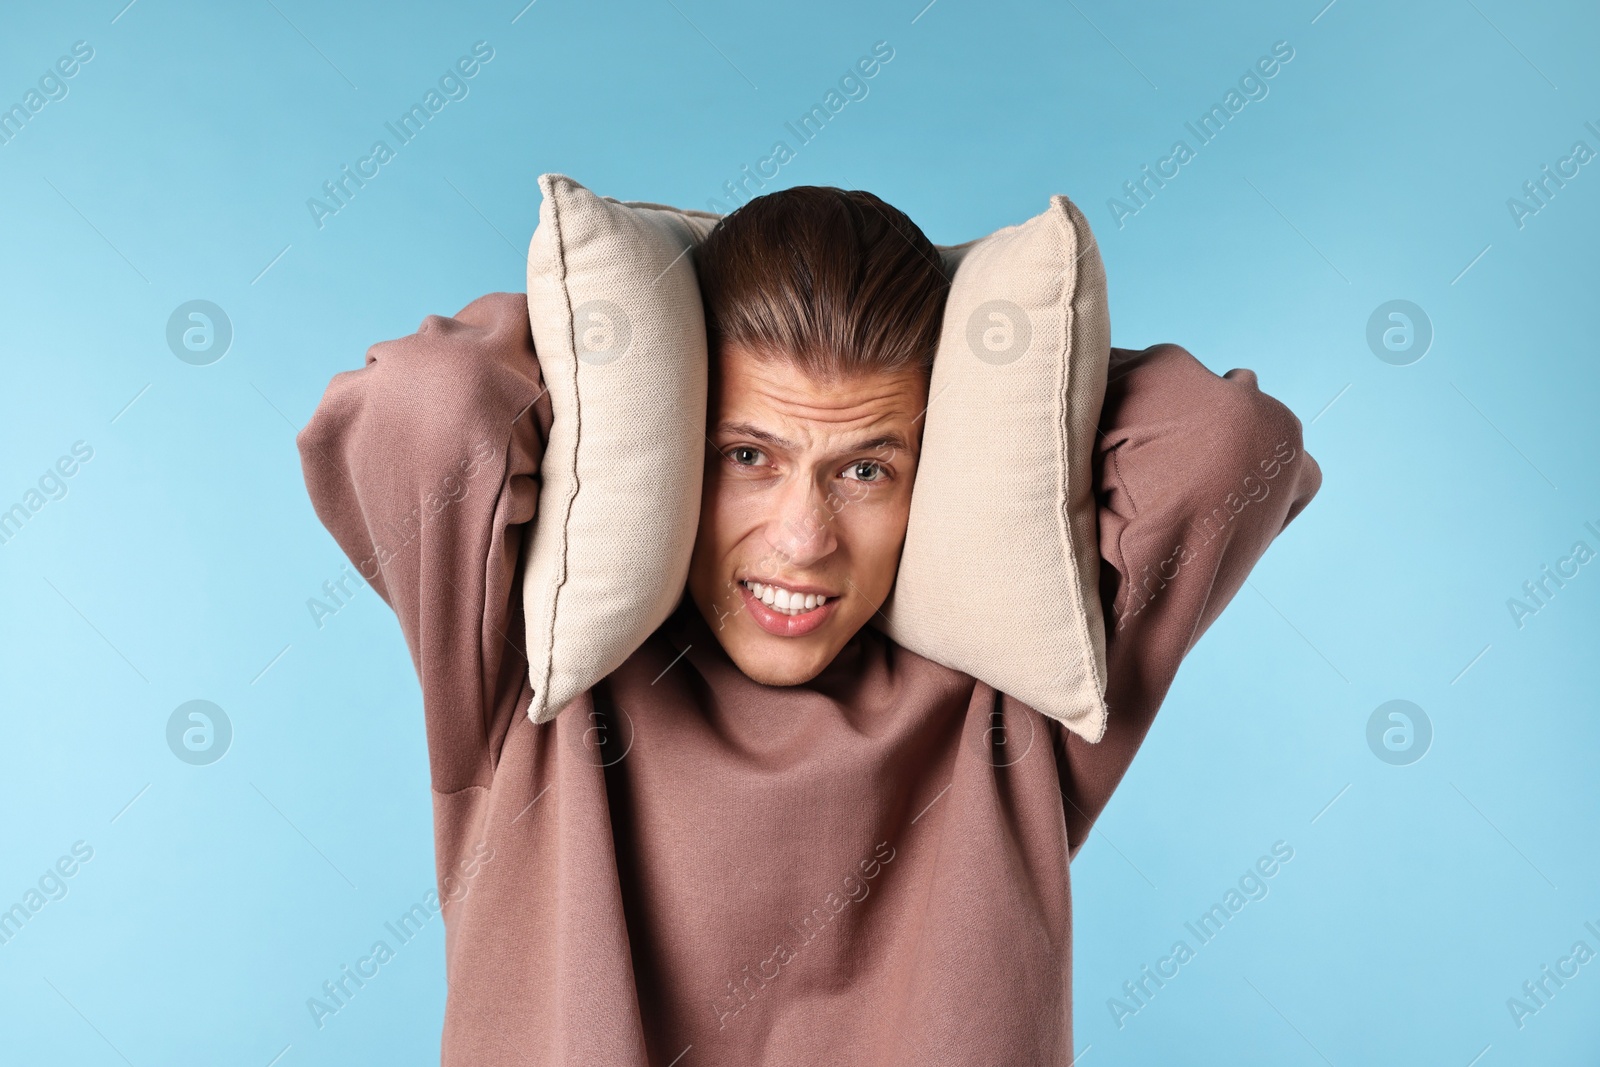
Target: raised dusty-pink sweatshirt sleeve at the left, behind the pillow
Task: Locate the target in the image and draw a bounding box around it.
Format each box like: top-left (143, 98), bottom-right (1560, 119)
top-left (296, 293), bottom-right (552, 793)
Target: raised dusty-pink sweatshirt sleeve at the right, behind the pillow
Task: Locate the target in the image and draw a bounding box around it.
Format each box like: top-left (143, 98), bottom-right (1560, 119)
top-left (1058, 344), bottom-right (1322, 856)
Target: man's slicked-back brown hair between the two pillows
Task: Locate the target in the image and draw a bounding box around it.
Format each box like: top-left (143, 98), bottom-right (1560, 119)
top-left (694, 186), bottom-right (950, 381)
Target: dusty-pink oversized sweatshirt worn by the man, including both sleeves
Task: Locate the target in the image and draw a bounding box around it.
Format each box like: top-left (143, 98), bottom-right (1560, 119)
top-left (299, 293), bottom-right (1322, 1067)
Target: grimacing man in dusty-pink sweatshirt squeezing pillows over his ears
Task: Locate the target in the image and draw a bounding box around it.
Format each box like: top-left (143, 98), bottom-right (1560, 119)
top-left (299, 189), bottom-right (1320, 1067)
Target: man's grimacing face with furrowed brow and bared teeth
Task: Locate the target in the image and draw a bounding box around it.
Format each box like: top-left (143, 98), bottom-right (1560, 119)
top-left (688, 347), bottom-right (928, 685)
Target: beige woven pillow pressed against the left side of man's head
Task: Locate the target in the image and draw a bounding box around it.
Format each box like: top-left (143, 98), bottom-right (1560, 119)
top-left (522, 174), bottom-right (717, 723)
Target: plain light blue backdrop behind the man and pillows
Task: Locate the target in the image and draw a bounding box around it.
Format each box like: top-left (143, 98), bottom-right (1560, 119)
top-left (0, 0), bottom-right (1600, 1067)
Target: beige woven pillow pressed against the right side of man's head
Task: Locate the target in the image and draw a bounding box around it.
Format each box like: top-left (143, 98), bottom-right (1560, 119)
top-left (874, 195), bottom-right (1110, 741)
